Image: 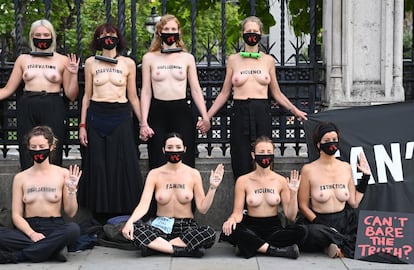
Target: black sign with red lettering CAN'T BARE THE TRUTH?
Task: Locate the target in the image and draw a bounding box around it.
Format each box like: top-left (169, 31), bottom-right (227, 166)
top-left (355, 210), bottom-right (414, 264)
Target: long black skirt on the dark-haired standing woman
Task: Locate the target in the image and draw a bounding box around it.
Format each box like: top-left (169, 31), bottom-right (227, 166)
top-left (78, 101), bottom-right (143, 214)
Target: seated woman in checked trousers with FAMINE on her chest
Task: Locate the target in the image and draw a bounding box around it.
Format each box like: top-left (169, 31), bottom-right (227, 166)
top-left (122, 133), bottom-right (224, 257)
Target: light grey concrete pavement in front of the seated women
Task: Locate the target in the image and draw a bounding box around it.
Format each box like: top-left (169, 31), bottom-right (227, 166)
top-left (0, 236), bottom-right (414, 270)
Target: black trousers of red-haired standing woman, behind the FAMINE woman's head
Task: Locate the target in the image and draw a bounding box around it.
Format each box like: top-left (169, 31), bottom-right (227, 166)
top-left (148, 98), bottom-right (196, 169)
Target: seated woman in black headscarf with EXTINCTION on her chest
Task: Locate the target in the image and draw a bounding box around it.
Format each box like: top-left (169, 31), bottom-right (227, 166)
top-left (298, 123), bottom-right (371, 258)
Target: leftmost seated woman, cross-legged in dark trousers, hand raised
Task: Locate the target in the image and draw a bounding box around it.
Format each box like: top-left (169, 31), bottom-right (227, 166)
top-left (0, 126), bottom-right (82, 263)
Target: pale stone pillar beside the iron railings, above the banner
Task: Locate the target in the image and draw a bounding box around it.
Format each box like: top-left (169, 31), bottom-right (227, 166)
top-left (322, 0), bottom-right (404, 109)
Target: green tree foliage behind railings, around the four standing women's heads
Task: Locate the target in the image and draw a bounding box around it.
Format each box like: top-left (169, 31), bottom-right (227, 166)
top-left (0, 0), bottom-right (275, 61)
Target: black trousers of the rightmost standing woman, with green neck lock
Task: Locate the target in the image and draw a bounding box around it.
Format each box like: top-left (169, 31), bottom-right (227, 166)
top-left (230, 99), bottom-right (272, 180)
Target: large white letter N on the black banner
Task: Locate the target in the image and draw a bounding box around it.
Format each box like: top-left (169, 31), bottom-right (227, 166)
top-left (374, 143), bottom-right (404, 183)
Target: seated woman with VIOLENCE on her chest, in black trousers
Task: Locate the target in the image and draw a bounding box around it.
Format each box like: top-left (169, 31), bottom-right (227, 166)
top-left (222, 136), bottom-right (305, 259)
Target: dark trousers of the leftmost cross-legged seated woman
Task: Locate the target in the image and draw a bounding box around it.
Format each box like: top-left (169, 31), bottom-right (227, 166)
top-left (0, 217), bottom-right (80, 262)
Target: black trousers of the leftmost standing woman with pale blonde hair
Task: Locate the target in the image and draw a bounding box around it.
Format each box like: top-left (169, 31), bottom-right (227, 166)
top-left (17, 91), bottom-right (67, 170)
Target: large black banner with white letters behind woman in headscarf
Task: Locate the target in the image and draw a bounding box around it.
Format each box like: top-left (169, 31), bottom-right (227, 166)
top-left (304, 102), bottom-right (414, 213)
